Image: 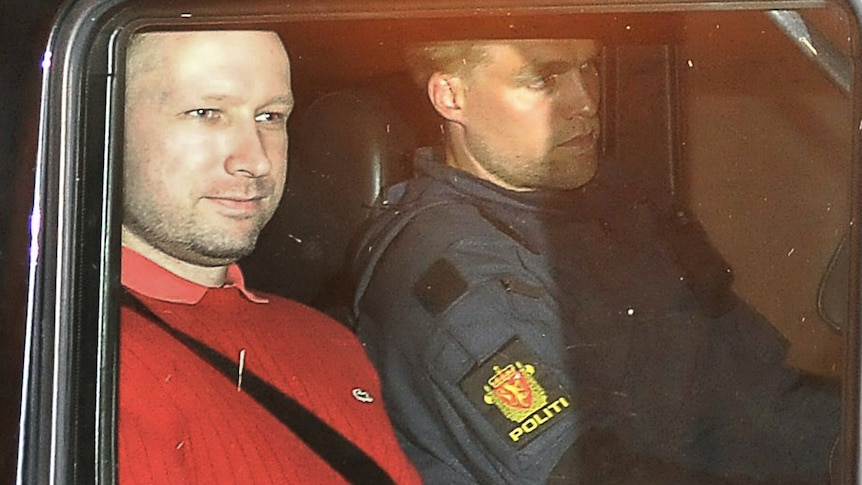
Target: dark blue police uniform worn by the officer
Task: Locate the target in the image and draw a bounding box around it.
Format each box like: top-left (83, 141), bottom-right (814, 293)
top-left (356, 148), bottom-right (840, 484)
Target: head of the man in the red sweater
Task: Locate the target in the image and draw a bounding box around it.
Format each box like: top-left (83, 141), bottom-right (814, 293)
top-left (123, 31), bottom-right (293, 266)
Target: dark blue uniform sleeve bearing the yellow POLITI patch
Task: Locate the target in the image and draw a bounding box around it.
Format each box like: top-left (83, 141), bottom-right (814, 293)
top-left (359, 208), bottom-right (576, 484)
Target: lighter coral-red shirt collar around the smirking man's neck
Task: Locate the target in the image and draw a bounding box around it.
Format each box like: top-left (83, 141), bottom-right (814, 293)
top-left (121, 246), bottom-right (268, 305)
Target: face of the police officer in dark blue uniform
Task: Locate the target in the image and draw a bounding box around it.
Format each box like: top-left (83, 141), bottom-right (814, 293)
top-left (456, 40), bottom-right (600, 190)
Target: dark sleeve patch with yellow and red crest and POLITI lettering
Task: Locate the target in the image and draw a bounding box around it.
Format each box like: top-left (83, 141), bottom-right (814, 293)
top-left (460, 337), bottom-right (573, 449)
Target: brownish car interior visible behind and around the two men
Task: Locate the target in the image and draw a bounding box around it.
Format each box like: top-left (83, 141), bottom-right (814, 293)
top-left (241, 9), bottom-right (852, 376)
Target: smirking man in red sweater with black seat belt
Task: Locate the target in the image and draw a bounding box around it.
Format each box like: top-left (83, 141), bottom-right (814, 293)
top-left (118, 31), bottom-right (419, 485)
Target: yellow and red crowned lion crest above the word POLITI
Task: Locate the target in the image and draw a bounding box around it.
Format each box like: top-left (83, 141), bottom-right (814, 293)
top-left (485, 362), bottom-right (548, 423)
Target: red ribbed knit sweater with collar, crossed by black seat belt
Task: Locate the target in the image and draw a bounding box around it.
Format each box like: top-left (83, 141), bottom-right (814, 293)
top-left (118, 249), bottom-right (420, 485)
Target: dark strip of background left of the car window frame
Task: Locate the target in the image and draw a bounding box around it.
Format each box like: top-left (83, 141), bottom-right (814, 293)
top-left (0, 0), bottom-right (65, 478)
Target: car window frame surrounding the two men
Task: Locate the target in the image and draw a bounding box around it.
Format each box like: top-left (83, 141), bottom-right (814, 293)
top-left (17, 0), bottom-right (862, 484)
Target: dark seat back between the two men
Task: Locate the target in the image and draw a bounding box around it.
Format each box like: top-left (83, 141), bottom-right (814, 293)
top-left (241, 75), bottom-right (436, 307)
